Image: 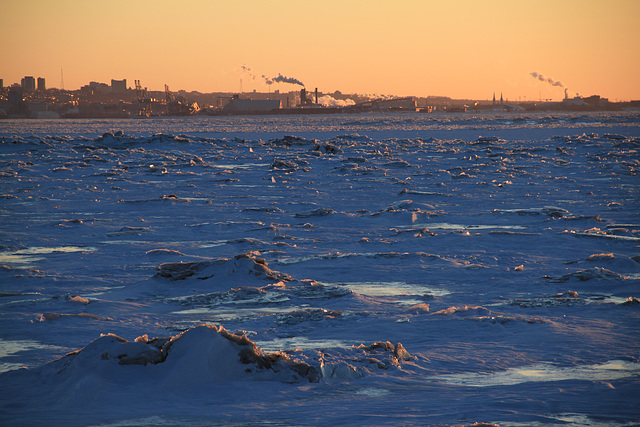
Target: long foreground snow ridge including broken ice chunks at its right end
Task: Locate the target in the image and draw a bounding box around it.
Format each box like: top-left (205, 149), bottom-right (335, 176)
top-left (37, 325), bottom-right (414, 390)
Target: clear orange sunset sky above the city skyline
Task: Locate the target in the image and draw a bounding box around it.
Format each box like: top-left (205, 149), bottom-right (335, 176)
top-left (0, 0), bottom-right (640, 101)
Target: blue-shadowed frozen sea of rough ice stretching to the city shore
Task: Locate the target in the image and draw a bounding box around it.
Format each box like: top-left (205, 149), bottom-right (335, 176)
top-left (0, 111), bottom-right (640, 427)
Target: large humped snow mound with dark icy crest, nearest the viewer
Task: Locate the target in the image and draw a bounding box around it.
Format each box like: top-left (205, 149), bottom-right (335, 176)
top-left (51, 325), bottom-right (320, 387)
